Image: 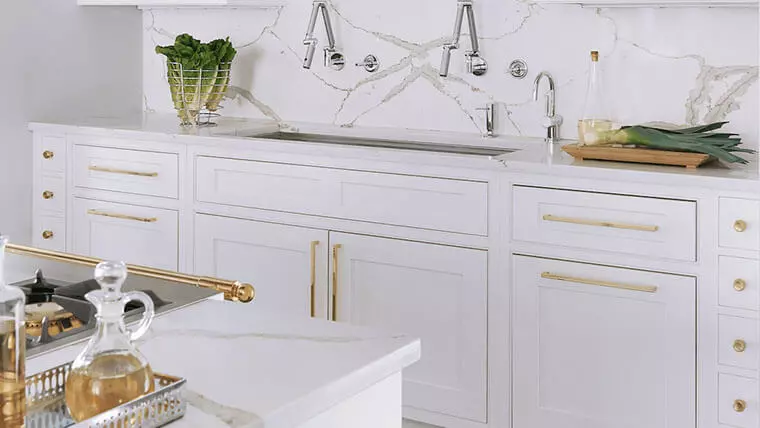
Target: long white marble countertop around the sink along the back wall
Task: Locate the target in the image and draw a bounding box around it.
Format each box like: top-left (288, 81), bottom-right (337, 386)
top-left (29, 113), bottom-right (760, 191)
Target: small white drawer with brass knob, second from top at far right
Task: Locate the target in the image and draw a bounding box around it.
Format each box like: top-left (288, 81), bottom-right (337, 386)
top-left (718, 256), bottom-right (760, 311)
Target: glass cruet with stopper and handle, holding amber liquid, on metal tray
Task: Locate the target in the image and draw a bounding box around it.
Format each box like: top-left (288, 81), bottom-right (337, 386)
top-left (66, 262), bottom-right (154, 422)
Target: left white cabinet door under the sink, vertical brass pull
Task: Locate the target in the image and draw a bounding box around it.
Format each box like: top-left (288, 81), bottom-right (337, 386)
top-left (195, 214), bottom-right (328, 318)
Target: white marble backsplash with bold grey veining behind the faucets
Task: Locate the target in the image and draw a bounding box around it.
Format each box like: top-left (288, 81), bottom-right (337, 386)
top-left (143, 0), bottom-right (759, 147)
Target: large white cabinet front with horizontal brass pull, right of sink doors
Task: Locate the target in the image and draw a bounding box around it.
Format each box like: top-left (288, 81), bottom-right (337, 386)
top-left (512, 256), bottom-right (696, 428)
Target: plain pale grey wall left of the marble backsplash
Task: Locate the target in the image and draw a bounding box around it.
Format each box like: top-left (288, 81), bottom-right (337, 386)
top-left (0, 0), bottom-right (142, 242)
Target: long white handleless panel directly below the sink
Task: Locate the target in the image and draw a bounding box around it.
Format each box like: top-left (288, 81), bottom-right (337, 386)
top-left (196, 156), bottom-right (488, 236)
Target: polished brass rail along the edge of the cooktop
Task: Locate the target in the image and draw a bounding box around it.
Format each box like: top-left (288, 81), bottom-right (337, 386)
top-left (5, 244), bottom-right (256, 303)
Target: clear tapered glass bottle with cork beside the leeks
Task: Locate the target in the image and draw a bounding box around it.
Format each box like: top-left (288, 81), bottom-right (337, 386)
top-left (578, 51), bottom-right (617, 145)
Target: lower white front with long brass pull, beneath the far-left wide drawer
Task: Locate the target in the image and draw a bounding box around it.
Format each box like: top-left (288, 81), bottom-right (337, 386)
top-left (70, 198), bottom-right (179, 270)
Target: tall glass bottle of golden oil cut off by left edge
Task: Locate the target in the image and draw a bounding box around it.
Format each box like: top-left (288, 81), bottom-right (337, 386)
top-left (0, 236), bottom-right (26, 428)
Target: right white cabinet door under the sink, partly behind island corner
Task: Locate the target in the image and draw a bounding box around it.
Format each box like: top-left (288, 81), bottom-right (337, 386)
top-left (330, 232), bottom-right (488, 422)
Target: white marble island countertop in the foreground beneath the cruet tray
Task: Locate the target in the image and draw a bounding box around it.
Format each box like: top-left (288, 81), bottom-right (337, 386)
top-left (26, 300), bottom-right (421, 428)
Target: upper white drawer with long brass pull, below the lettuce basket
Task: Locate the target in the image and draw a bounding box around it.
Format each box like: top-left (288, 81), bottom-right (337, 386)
top-left (73, 145), bottom-right (179, 199)
